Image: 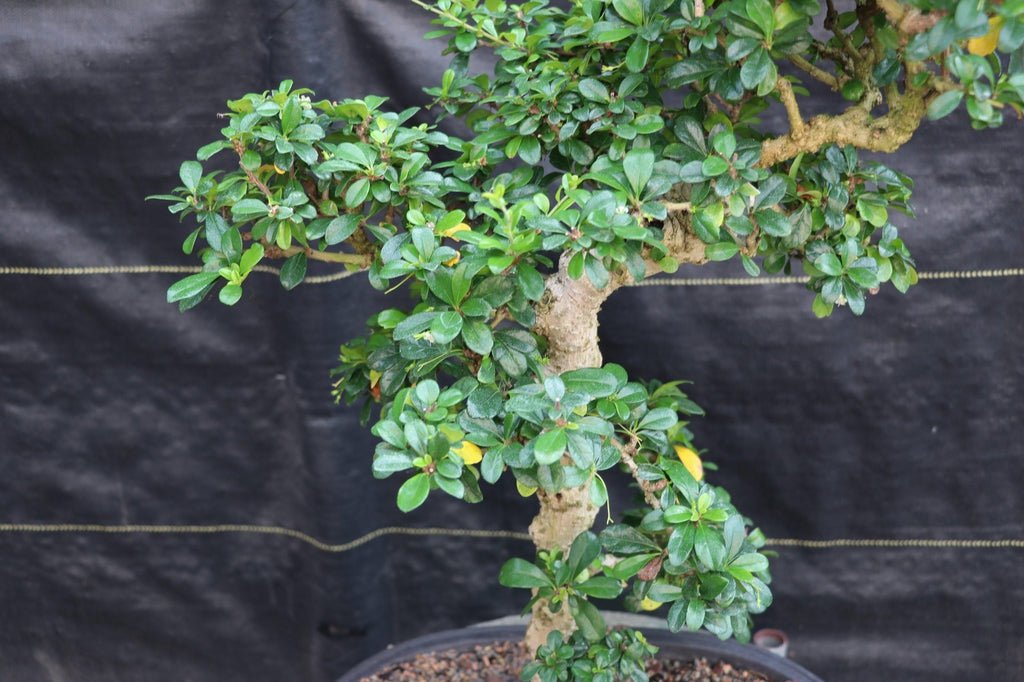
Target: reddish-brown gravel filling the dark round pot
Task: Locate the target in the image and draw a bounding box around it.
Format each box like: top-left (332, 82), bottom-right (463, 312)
top-left (361, 642), bottom-right (770, 682)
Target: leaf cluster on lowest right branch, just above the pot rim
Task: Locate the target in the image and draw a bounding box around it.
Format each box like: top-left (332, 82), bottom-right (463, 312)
top-left (500, 450), bottom-right (772, 641)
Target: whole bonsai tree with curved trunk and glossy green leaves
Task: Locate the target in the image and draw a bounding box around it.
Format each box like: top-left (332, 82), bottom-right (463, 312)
top-left (151, 0), bottom-right (1024, 680)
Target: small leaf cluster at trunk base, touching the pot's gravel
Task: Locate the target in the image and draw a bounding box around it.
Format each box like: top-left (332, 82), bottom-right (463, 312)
top-left (519, 628), bottom-right (657, 682)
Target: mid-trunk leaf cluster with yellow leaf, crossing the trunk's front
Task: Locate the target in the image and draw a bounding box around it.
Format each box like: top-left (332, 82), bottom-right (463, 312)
top-left (352, 356), bottom-right (701, 511)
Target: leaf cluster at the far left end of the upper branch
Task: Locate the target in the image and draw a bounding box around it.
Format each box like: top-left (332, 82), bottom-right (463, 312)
top-left (151, 81), bottom-right (449, 309)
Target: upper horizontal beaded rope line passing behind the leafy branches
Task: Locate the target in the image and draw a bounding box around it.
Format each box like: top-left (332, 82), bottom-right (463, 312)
top-left (0, 265), bottom-right (1024, 287)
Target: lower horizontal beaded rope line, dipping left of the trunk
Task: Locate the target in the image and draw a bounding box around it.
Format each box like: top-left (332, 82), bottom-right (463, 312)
top-left (0, 523), bottom-right (1024, 554)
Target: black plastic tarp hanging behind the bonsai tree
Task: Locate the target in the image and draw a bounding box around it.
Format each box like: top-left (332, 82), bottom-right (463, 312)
top-left (0, 0), bottom-right (1024, 682)
